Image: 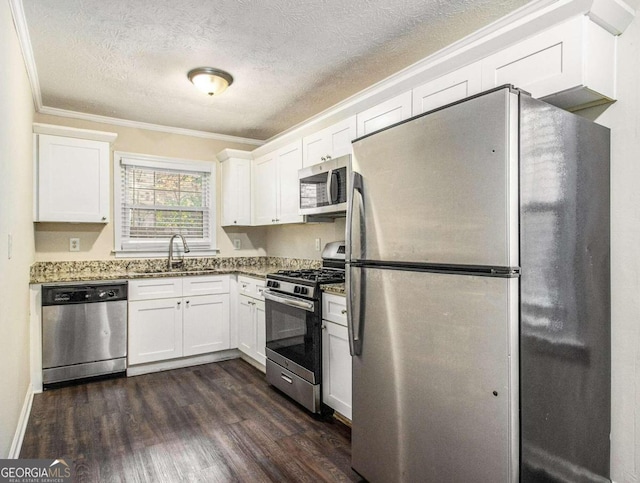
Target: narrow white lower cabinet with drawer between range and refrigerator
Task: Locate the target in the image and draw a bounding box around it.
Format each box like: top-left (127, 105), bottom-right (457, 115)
top-left (322, 294), bottom-right (352, 419)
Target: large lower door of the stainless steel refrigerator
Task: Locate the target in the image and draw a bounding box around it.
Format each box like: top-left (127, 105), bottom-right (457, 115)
top-left (350, 267), bottom-right (519, 483)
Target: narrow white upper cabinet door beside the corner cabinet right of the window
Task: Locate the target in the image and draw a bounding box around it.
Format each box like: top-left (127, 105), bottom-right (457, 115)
top-left (251, 153), bottom-right (277, 225)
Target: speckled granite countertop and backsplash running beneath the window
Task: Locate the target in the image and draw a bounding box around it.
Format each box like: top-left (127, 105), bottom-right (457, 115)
top-left (30, 257), bottom-right (321, 284)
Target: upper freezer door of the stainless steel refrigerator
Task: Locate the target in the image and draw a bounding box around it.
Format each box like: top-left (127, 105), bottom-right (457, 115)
top-left (348, 88), bottom-right (518, 267)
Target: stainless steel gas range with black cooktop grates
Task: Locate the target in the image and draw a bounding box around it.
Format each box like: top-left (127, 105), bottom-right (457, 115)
top-left (263, 242), bottom-right (345, 413)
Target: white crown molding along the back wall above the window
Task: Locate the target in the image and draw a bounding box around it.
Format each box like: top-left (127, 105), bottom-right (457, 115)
top-left (38, 106), bottom-right (265, 146)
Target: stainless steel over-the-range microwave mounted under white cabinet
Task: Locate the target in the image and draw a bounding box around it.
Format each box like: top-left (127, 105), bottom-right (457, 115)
top-left (298, 155), bottom-right (351, 215)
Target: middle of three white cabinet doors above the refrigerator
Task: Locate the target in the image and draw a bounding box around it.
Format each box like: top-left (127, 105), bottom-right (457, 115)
top-left (412, 62), bottom-right (482, 116)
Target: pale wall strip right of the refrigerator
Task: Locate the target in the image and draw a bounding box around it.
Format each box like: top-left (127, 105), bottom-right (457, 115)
top-left (578, 16), bottom-right (640, 483)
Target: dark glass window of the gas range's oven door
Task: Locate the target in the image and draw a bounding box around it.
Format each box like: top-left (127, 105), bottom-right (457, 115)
top-left (265, 300), bottom-right (320, 377)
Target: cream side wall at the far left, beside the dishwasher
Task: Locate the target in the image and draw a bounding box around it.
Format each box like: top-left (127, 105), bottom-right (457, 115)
top-left (0, 1), bottom-right (34, 458)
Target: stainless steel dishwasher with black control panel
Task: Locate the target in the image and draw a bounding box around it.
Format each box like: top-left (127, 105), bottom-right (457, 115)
top-left (42, 282), bottom-right (127, 387)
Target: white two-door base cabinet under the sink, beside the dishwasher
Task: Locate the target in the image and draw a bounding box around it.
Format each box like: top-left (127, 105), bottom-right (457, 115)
top-left (128, 276), bottom-right (230, 366)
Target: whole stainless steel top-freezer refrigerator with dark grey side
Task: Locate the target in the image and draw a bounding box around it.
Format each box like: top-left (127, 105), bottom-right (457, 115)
top-left (347, 86), bottom-right (610, 483)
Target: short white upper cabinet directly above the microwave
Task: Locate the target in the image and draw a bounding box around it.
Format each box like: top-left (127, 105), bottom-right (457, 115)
top-left (302, 116), bottom-right (356, 168)
